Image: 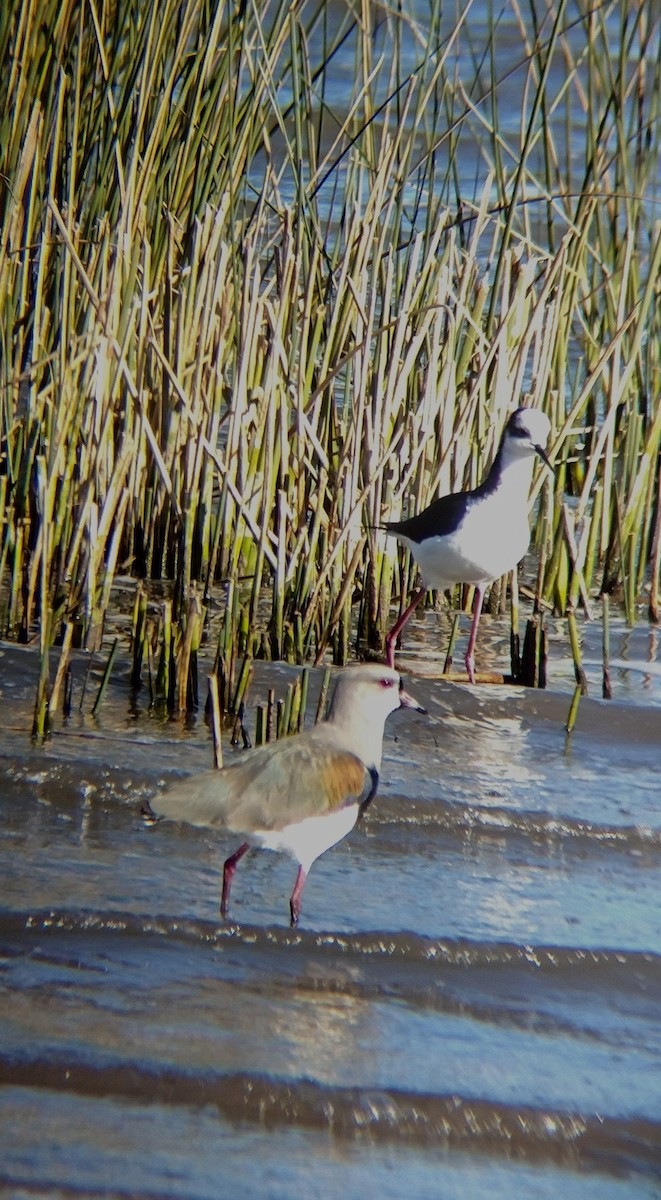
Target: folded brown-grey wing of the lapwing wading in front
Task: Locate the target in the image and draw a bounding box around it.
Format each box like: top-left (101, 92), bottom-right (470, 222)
top-left (150, 737), bottom-right (372, 833)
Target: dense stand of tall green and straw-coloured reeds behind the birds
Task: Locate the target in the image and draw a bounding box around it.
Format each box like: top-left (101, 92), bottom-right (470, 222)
top-left (0, 0), bottom-right (661, 731)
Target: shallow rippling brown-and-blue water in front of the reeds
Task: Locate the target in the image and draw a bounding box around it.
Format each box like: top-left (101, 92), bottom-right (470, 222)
top-left (0, 647), bottom-right (661, 1200)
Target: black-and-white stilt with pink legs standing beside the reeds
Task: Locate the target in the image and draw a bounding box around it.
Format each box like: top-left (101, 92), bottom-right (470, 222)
top-left (381, 408), bottom-right (553, 683)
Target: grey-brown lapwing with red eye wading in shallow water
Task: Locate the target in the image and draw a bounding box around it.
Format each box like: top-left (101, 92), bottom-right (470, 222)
top-left (143, 662), bottom-right (425, 925)
